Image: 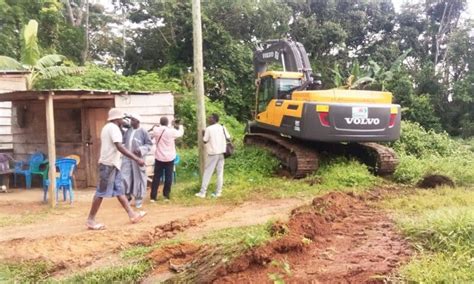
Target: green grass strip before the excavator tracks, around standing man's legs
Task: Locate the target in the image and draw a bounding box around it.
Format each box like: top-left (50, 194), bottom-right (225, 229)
top-left (168, 147), bottom-right (381, 205)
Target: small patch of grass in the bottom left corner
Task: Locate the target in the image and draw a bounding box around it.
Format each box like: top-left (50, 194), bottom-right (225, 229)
top-left (0, 260), bottom-right (54, 283)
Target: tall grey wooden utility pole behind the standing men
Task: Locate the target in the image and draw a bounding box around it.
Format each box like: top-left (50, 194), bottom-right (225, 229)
top-left (193, 0), bottom-right (206, 176)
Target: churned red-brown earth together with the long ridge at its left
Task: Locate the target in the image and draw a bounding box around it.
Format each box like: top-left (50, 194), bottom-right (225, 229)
top-left (145, 192), bottom-right (411, 283)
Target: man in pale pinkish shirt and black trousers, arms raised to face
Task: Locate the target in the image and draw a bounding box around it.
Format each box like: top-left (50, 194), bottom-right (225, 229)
top-left (150, 116), bottom-right (184, 202)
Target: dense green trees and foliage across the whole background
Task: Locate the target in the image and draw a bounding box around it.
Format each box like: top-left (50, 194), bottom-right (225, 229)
top-left (0, 0), bottom-right (474, 137)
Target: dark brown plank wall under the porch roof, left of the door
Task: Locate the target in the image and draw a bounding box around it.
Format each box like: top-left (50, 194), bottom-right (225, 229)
top-left (12, 101), bottom-right (86, 188)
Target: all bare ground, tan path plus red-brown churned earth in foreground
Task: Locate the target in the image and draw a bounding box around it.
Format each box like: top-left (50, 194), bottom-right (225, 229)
top-left (0, 186), bottom-right (410, 283)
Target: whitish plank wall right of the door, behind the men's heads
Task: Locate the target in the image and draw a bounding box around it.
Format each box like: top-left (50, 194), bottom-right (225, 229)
top-left (115, 93), bottom-right (174, 176)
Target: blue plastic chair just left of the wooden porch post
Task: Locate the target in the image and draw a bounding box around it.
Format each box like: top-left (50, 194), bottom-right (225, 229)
top-left (13, 152), bottom-right (48, 188)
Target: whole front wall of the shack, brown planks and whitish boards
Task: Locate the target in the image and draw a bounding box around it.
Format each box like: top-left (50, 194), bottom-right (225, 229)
top-left (12, 93), bottom-right (174, 188)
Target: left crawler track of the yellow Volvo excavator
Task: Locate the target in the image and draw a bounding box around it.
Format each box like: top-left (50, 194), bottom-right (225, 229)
top-left (244, 133), bottom-right (319, 178)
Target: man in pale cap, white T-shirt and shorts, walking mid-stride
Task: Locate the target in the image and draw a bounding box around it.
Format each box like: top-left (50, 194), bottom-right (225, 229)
top-left (86, 108), bottom-right (146, 230)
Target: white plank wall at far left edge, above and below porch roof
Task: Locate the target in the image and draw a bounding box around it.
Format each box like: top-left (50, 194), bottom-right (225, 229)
top-left (0, 74), bottom-right (26, 151)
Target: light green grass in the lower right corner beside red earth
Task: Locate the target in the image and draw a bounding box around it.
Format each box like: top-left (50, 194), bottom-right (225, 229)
top-left (382, 188), bottom-right (474, 283)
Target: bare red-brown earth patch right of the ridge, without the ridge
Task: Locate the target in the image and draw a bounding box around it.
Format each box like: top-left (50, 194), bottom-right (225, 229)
top-left (214, 193), bottom-right (410, 283)
